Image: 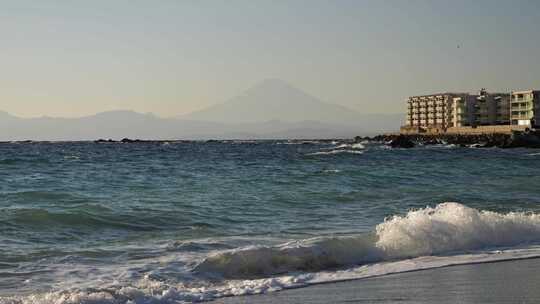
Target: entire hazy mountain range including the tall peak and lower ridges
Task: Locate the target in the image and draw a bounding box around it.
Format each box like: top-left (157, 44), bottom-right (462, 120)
top-left (0, 79), bottom-right (404, 141)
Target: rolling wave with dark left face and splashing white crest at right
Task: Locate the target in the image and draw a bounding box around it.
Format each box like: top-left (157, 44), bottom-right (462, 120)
top-left (194, 203), bottom-right (540, 279)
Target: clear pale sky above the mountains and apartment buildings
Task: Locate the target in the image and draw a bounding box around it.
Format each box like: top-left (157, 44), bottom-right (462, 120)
top-left (0, 0), bottom-right (540, 117)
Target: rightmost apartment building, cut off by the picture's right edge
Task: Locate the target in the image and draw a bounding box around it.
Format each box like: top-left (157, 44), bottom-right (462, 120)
top-left (510, 90), bottom-right (540, 127)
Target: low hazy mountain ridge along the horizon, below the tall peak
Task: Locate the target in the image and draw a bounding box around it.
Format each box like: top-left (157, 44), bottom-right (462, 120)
top-left (0, 111), bottom-right (384, 141)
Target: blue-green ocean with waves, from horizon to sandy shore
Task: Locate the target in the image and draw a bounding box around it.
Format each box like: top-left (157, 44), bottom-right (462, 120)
top-left (0, 141), bottom-right (540, 304)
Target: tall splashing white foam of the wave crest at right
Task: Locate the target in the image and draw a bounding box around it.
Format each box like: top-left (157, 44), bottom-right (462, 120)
top-left (376, 203), bottom-right (540, 258)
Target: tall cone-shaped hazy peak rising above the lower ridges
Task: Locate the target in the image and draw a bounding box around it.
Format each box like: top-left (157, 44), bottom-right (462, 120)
top-left (184, 79), bottom-right (361, 124)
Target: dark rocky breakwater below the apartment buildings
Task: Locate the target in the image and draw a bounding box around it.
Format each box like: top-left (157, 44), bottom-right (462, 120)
top-left (365, 131), bottom-right (540, 148)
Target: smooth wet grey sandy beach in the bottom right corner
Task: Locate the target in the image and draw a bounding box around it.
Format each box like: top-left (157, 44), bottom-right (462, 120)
top-left (212, 259), bottom-right (540, 304)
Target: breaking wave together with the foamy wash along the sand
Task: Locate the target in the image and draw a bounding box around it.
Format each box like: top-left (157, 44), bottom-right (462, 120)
top-left (6, 203), bottom-right (540, 304)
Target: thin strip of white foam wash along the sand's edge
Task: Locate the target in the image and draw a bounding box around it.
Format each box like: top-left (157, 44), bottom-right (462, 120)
top-left (5, 248), bottom-right (540, 304)
